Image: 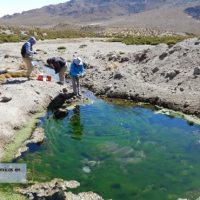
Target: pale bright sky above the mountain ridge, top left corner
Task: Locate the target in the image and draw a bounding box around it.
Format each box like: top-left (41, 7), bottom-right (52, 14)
top-left (0, 0), bottom-right (68, 17)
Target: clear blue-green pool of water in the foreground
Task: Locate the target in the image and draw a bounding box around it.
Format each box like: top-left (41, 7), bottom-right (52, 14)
top-left (18, 94), bottom-right (200, 200)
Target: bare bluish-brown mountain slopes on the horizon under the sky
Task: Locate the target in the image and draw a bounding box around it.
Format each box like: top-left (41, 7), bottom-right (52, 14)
top-left (0, 0), bottom-right (200, 33)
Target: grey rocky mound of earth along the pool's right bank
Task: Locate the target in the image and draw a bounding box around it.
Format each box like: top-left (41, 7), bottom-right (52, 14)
top-left (80, 39), bottom-right (200, 116)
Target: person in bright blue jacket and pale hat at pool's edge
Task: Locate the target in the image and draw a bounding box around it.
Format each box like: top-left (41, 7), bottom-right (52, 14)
top-left (69, 57), bottom-right (85, 97)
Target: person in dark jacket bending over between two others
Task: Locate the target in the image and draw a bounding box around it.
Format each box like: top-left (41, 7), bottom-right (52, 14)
top-left (47, 57), bottom-right (67, 85)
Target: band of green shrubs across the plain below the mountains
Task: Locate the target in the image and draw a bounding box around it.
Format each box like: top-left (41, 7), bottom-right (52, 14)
top-left (0, 26), bottom-right (198, 44)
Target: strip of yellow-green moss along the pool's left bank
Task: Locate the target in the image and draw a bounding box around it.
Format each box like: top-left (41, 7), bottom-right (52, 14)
top-left (1, 113), bottom-right (44, 162)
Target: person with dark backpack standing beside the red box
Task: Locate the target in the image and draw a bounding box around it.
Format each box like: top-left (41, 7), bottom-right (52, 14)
top-left (21, 37), bottom-right (37, 80)
